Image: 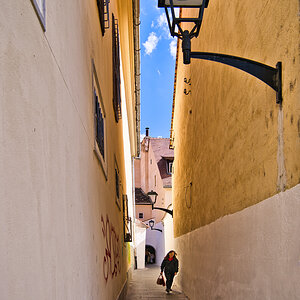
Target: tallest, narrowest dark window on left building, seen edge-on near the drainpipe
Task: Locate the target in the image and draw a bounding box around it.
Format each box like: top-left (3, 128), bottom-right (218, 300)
top-left (112, 15), bottom-right (122, 122)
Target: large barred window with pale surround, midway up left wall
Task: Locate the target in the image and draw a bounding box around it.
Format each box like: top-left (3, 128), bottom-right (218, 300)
top-left (92, 62), bottom-right (107, 179)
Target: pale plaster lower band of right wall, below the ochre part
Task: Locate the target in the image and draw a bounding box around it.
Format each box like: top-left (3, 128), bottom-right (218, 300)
top-left (175, 185), bottom-right (300, 300)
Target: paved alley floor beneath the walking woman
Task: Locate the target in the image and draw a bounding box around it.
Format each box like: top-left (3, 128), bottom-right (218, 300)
top-left (126, 266), bottom-right (188, 300)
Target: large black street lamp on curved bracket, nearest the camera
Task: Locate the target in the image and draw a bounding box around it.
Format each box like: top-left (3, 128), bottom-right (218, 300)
top-left (158, 0), bottom-right (282, 104)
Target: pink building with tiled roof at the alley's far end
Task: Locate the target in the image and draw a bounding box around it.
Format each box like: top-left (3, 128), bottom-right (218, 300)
top-left (134, 129), bottom-right (174, 264)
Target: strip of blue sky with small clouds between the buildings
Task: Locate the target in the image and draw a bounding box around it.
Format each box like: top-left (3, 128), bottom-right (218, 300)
top-left (140, 0), bottom-right (177, 137)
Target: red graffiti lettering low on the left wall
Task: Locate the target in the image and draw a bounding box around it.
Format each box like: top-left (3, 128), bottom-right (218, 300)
top-left (101, 215), bottom-right (121, 282)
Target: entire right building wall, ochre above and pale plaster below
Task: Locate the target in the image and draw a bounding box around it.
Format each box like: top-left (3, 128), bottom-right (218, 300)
top-left (171, 0), bottom-right (300, 299)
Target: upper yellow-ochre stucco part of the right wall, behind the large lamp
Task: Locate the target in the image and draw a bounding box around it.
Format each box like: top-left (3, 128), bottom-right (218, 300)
top-left (173, 0), bottom-right (300, 236)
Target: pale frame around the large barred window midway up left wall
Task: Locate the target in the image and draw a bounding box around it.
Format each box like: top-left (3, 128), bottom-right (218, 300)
top-left (92, 60), bottom-right (107, 180)
